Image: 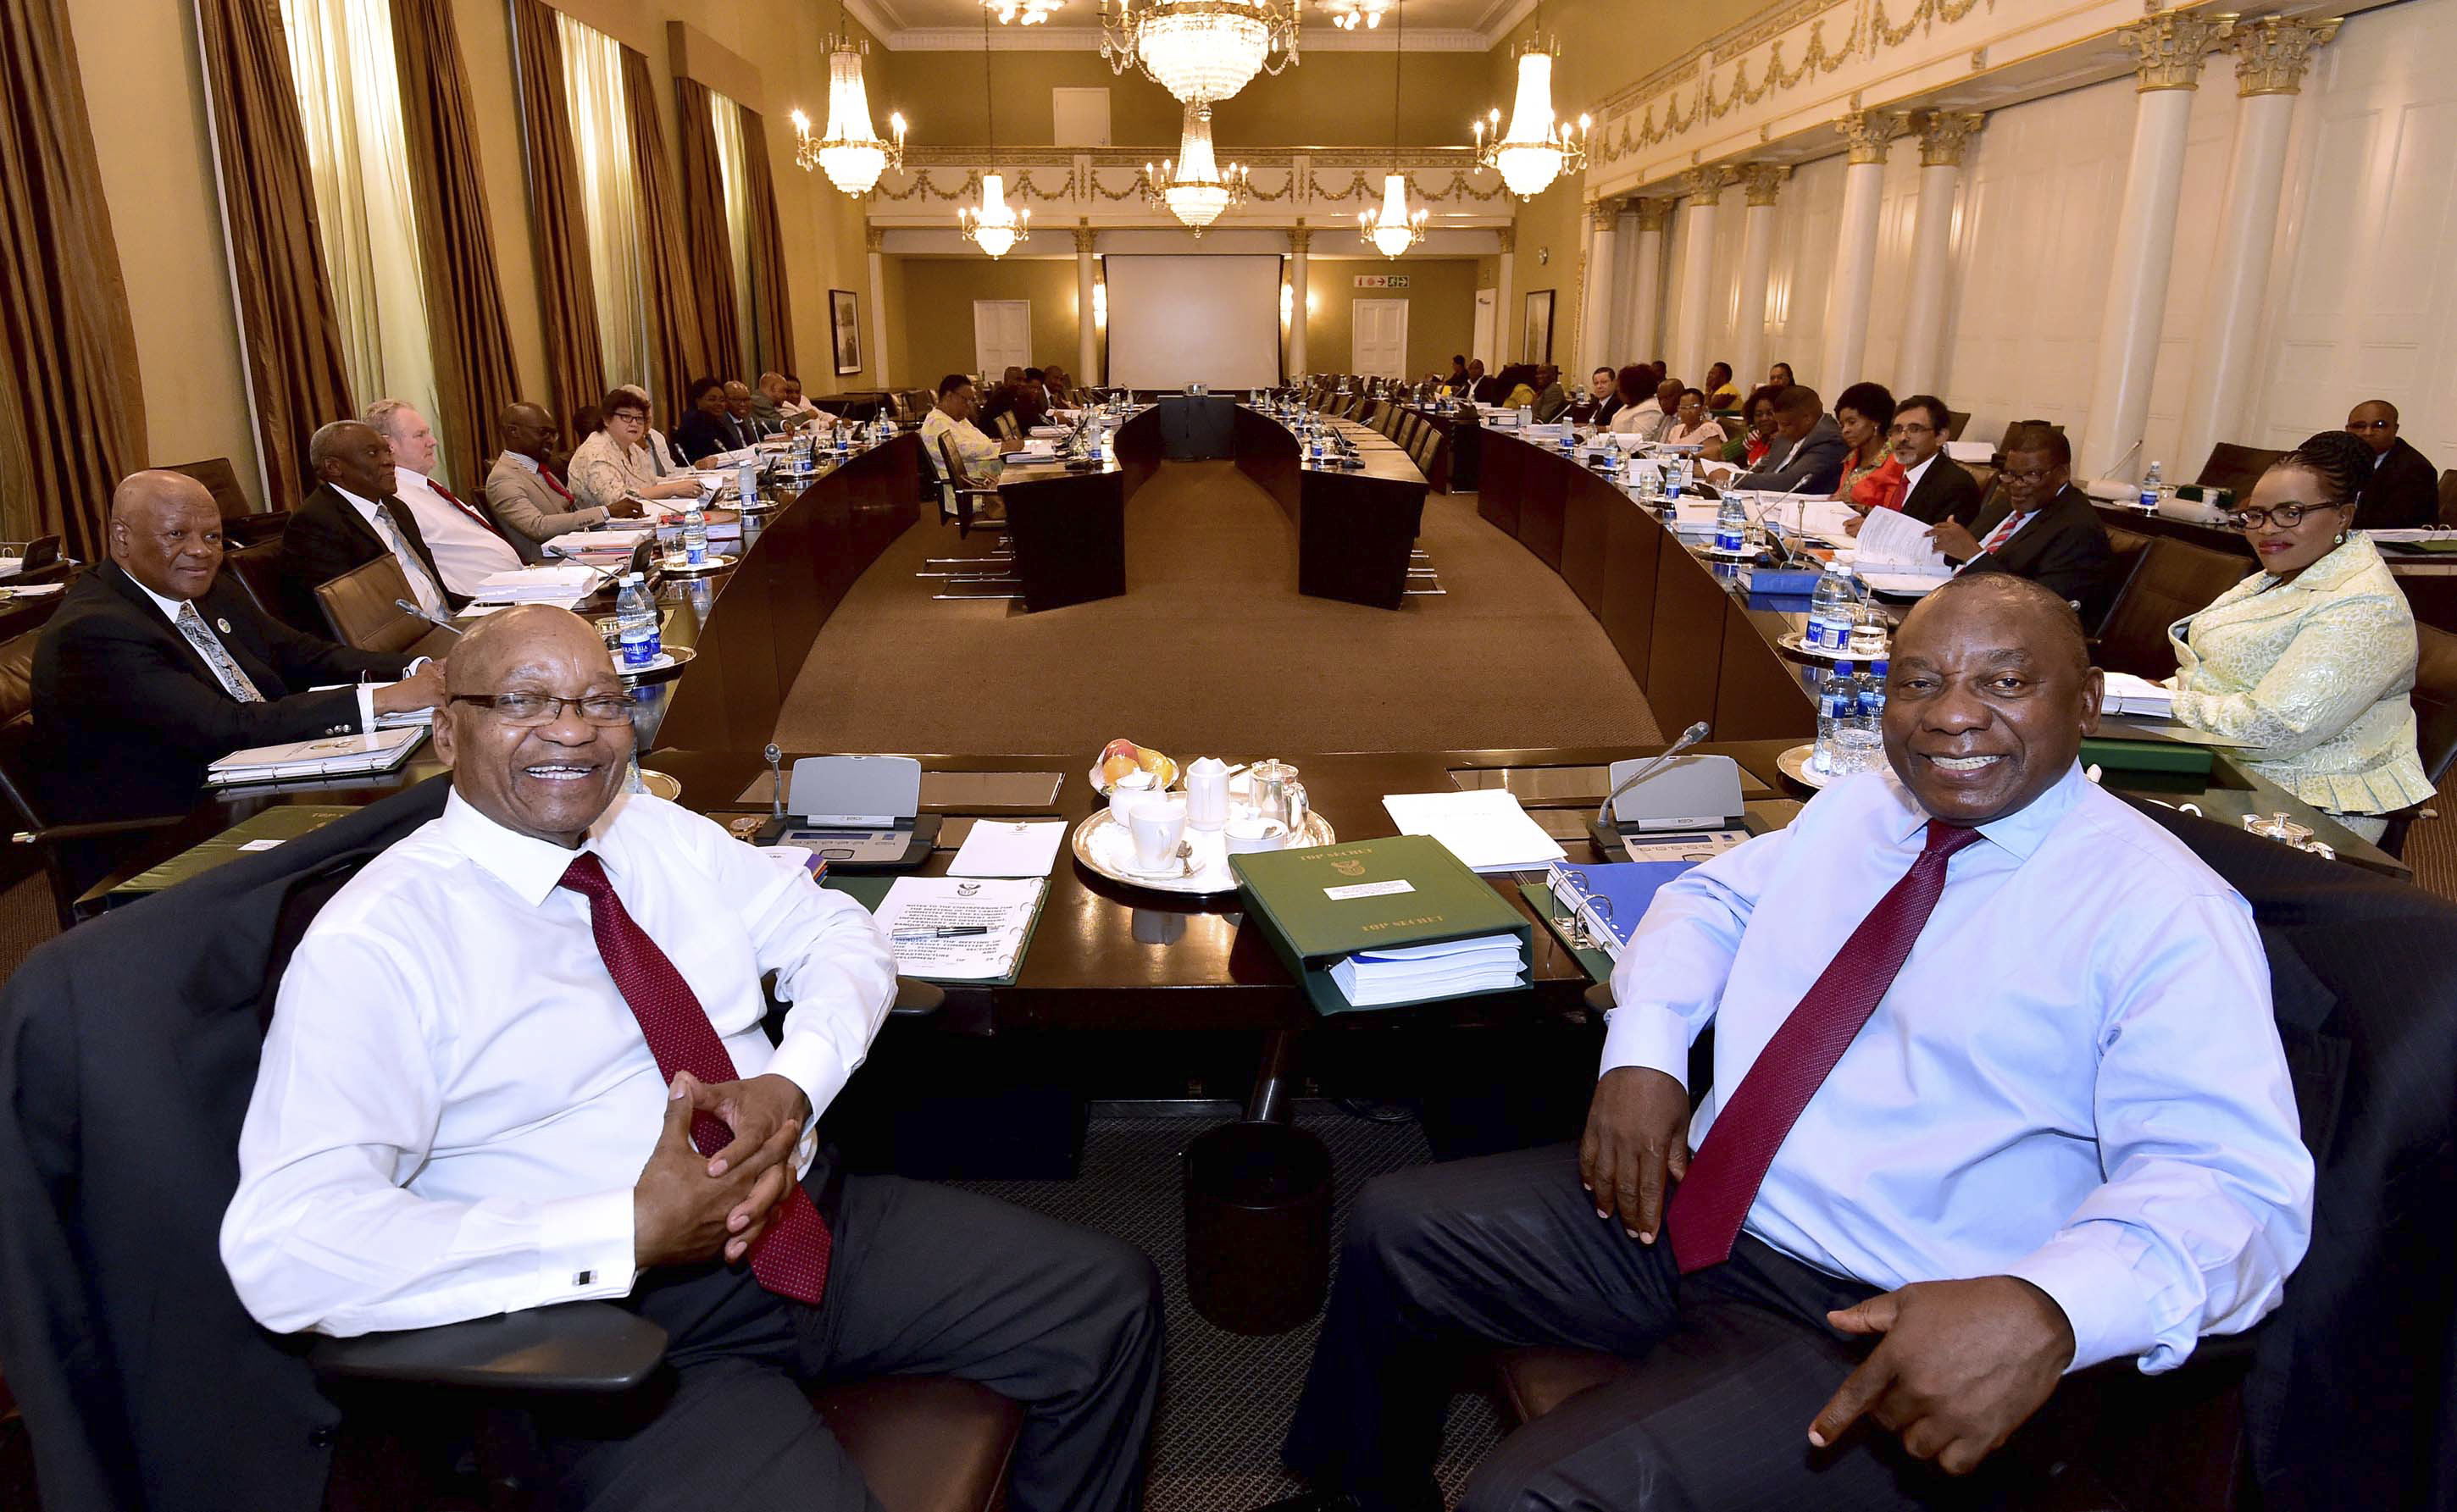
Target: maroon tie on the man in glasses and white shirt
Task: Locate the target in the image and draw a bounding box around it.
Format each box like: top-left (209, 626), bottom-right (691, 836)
top-left (563, 852), bottom-right (833, 1306)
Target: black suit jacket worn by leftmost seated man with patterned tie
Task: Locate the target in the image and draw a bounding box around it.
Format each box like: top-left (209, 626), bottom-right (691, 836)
top-left (35, 562), bottom-right (408, 822)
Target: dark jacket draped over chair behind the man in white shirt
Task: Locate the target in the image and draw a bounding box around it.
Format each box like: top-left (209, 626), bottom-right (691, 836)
top-left (0, 778), bottom-right (450, 1512)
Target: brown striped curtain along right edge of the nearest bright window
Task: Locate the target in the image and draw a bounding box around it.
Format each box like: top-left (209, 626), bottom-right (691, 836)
top-left (393, 0), bottom-right (521, 491)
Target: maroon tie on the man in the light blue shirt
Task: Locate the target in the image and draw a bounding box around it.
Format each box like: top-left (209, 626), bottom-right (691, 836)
top-left (1663, 820), bottom-right (1980, 1277)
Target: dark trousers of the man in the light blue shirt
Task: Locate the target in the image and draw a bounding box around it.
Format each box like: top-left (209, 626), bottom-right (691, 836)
top-left (1288, 1144), bottom-right (1998, 1512)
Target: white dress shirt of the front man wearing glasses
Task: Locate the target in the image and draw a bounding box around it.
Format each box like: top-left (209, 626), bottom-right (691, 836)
top-left (221, 793), bottom-right (895, 1335)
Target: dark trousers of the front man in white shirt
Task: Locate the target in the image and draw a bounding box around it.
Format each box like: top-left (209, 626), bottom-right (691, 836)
top-left (535, 1176), bottom-right (1160, 1512)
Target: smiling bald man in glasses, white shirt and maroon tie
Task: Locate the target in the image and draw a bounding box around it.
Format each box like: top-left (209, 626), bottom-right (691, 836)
top-left (221, 606), bottom-right (1160, 1512)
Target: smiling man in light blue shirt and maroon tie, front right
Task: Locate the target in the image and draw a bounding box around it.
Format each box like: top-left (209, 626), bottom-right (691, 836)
top-left (1288, 574), bottom-right (2312, 1512)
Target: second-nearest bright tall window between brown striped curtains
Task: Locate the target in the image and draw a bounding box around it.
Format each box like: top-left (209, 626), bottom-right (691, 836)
top-left (555, 12), bottom-right (648, 395)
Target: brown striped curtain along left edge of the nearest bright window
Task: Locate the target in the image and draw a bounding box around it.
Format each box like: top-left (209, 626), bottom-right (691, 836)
top-left (197, 0), bottom-right (357, 508)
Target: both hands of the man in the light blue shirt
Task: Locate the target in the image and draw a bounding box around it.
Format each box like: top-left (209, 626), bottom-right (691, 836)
top-left (1578, 1066), bottom-right (2074, 1476)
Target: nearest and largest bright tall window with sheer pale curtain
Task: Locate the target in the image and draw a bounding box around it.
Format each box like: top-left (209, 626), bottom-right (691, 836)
top-left (280, 0), bottom-right (435, 476)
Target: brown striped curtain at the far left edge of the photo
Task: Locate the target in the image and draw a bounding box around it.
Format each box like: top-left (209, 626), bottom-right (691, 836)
top-left (0, 0), bottom-right (145, 562)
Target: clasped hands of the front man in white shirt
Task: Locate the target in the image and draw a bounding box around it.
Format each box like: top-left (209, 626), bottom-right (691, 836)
top-left (631, 1070), bottom-right (811, 1269)
